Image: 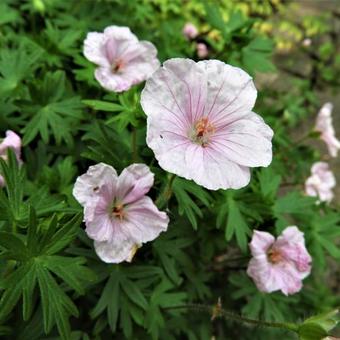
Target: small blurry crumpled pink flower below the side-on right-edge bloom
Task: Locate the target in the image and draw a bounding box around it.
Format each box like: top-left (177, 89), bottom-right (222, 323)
top-left (305, 162), bottom-right (336, 203)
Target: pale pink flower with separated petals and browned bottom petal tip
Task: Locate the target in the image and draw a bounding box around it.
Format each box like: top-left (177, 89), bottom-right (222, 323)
top-left (73, 163), bottom-right (169, 263)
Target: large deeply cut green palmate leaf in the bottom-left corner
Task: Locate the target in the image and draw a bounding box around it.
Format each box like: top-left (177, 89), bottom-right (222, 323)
top-left (0, 209), bottom-right (94, 339)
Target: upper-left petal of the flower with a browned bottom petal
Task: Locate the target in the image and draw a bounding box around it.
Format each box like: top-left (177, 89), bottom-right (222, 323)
top-left (72, 163), bottom-right (118, 206)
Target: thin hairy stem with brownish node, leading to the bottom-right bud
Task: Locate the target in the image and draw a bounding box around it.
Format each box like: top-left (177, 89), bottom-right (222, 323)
top-left (164, 304), bottom-right (299, 332)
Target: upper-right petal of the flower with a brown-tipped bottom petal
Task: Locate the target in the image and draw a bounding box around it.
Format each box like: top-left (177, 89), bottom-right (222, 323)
top-left (116, 164), bottom-right (154, 204)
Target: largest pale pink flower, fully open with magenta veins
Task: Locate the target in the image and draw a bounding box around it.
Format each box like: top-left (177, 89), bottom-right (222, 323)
top-left (141, 58), bottom-right (273, 190)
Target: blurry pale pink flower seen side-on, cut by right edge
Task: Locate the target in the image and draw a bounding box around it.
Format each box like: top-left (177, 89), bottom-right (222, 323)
top-left (315, 103), bottom-right (340, 157)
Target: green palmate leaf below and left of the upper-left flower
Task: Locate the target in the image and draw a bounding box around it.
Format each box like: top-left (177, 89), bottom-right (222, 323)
top-left (23, 71), bottom-right (83, 145)
